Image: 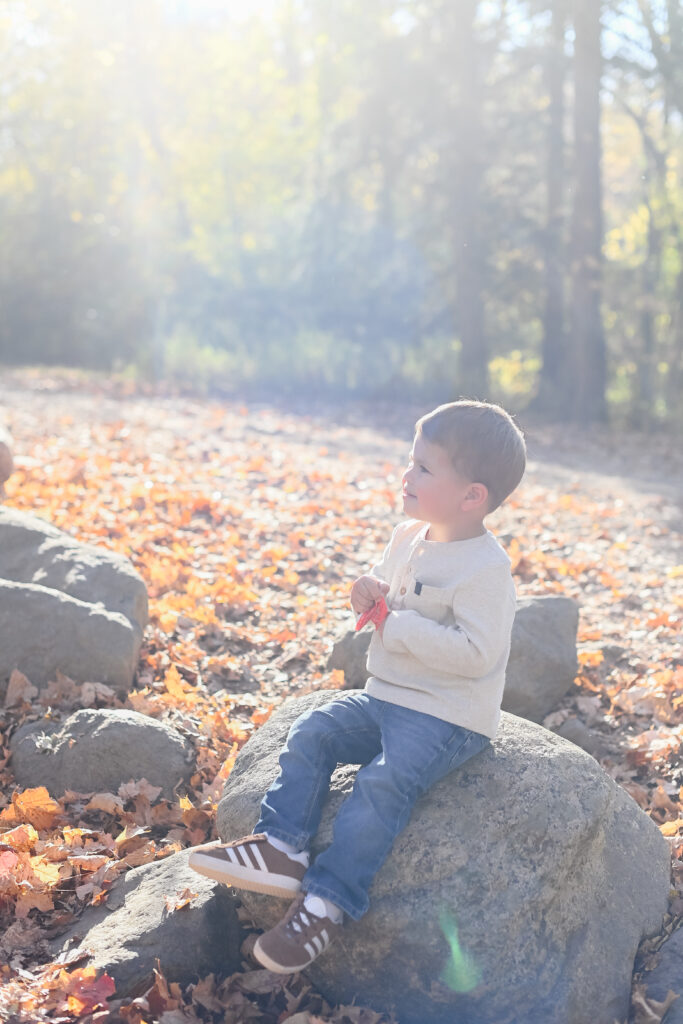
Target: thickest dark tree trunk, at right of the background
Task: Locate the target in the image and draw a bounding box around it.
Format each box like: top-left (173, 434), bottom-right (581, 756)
top-left (567, 0), bottom-right (607, 423)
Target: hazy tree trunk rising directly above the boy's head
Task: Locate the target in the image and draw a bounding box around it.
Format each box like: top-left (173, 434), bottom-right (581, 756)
top-left (452, 0), bottom-right (488, 399)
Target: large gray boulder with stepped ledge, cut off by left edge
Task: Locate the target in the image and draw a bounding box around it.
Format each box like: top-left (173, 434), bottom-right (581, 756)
top-left (0, 508), bottom-right (147, 691)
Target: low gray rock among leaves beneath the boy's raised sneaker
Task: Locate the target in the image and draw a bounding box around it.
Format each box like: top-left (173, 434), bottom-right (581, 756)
top-left (52, 851), bottom-right (241, 998)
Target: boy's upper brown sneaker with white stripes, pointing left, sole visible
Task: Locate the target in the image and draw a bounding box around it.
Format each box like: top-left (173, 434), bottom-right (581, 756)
top-left (187, 833), bottom-right (306, 896)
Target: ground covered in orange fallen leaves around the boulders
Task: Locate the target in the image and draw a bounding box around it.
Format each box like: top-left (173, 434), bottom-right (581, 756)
top-left (0, 371), bottom-right (683, 1024)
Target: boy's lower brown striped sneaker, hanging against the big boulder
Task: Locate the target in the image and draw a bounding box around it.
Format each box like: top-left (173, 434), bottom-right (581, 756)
top-left (254, 893), bottom-right (342, 974)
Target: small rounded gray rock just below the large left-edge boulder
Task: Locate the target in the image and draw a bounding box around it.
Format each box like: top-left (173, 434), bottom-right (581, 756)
top-left (9, 709), bottom-right (194, 798)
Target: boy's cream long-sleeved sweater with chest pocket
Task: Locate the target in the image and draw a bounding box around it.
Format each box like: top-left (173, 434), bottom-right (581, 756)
top-left (366, 519), bottom-right (516, 739)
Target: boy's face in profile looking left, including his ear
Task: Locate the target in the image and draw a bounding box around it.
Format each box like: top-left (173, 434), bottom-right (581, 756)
top-left (402, 436), bottom-right (487, 523)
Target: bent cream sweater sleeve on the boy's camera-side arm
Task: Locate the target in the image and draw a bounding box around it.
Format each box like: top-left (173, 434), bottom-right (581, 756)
top-left (382, 567), bottom-right (516, 679)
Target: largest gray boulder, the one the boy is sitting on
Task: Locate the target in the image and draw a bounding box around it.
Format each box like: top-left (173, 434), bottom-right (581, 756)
top-left (218, 691), bottom-right (671, 1024)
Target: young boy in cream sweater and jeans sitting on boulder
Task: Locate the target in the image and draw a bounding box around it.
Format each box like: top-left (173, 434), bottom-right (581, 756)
top-left (189, 399), bottom-right (526, 973)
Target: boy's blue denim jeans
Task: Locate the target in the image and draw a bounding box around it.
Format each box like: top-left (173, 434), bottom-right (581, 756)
top-left (254, 692), bottom-right (490, 921)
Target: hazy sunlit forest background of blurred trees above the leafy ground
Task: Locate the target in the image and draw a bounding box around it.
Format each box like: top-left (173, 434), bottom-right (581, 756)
top-left (0, 0), bottom-right (683, 430)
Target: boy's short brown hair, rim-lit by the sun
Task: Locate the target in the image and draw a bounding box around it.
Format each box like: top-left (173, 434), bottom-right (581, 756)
top-left (415, 398), bottom-right (526, 515)
